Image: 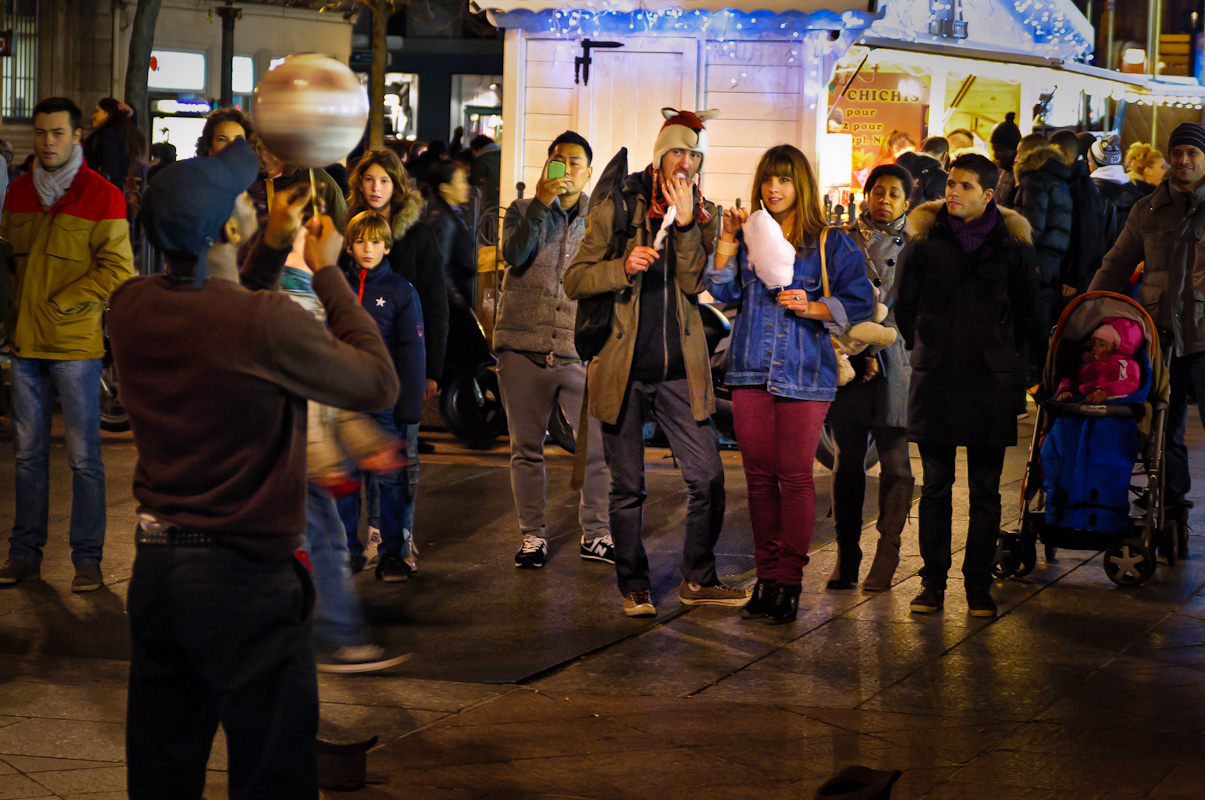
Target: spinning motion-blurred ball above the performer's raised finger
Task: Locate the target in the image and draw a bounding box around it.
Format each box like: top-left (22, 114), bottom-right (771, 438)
top-left (251, 53), bottom-right (369, 166)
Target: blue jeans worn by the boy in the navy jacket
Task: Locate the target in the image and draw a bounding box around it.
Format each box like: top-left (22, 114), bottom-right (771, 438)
top-left (339, 408), bottom-right (418, 558)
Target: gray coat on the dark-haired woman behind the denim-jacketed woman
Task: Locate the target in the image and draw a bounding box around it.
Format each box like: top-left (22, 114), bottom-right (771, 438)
top-left (829, 209), bottom-right (912, 428)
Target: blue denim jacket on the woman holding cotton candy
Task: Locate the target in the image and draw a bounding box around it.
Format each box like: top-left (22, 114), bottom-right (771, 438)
top-left (706, 229), bottom-right (874, 401)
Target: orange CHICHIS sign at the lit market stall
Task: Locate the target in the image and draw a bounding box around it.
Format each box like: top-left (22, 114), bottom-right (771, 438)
top-left (829, 72), bottom-right (929, 188)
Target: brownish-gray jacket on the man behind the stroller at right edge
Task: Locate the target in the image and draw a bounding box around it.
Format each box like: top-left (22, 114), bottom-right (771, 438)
top-left (1088, 180), bottom-right (1205, 355)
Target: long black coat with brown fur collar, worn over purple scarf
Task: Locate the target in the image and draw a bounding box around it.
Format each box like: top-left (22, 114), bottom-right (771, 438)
top-left (894, 200), bottom-right (1038, 447)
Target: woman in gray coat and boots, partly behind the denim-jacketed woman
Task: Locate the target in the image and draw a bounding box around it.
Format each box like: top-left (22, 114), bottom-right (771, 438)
top-left (827, 164), bottom-right (916, 592)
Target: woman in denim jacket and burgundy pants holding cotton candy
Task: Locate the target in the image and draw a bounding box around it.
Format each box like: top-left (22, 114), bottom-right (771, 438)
top-left (707, 145), bottom-right (874, 624)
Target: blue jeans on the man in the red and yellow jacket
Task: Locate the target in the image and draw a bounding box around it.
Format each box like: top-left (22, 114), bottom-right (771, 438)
top-left (8, 358), bottom-right (105, 564)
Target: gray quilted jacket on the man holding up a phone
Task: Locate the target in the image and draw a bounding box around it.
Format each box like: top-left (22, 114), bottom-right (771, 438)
top-left (494, 193), bottom-right (589, 359)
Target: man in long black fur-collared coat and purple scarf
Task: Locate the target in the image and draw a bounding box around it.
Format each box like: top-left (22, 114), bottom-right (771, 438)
top-left (894, 153), bottom-right (1038, 617)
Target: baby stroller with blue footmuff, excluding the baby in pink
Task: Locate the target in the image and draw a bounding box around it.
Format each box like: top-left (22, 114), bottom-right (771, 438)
top-left (993, 292), bottom-right (1188, 586)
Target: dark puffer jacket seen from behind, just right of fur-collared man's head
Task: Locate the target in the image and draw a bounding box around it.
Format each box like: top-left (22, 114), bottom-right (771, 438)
top-left (1012, 145), bottom-right (1072, 295)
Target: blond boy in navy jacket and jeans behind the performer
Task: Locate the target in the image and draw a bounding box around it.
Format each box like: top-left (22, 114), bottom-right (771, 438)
top-left (339, 211), bottom-right (427, 583)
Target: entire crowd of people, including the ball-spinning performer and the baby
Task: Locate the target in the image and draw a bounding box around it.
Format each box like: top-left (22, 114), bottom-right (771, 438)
top-left (0, 98), bottom-right (1205, 798)
